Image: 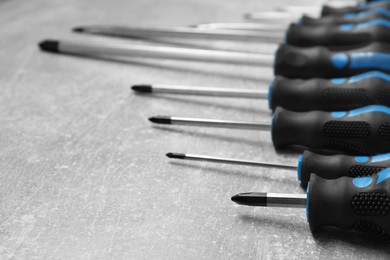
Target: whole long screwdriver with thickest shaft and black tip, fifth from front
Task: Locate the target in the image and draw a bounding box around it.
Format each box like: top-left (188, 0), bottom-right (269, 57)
top-left (39, 40), bottom-right (390, 79)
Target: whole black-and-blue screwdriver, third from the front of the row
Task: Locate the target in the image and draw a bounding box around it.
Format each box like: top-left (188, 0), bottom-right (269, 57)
top-left (149, 105), bottom-right (390, 155)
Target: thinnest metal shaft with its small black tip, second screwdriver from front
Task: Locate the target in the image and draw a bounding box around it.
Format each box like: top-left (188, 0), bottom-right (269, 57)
top-left (167, 153), bottom-right (297, 171)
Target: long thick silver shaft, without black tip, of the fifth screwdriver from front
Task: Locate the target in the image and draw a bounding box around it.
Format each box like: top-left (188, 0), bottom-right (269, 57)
top-left (59, 40), bottom-right (273, 66)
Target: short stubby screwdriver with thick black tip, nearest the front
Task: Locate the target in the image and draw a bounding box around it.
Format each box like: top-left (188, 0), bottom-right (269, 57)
top-left (231, 172), bottom-right (390, 240)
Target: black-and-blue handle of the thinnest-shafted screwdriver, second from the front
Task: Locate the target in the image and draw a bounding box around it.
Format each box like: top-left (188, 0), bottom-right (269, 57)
top-left (297, 151), bottom-right (390, 187)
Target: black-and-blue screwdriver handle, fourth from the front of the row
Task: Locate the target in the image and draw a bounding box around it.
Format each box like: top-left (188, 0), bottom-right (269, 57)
top-left (269, 71), bottom-right (390, 112)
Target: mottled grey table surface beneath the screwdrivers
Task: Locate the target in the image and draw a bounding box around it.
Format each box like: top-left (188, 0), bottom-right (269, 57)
top-left (0, 0), bottom-right (390, 259)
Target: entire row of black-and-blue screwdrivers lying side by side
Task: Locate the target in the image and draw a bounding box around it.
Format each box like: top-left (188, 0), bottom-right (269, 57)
top-left (39, 0), bottom-right (390, 244)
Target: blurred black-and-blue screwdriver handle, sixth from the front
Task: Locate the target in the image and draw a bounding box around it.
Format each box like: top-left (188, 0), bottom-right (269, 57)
top-left (286, 19), bottom-right (390, 47)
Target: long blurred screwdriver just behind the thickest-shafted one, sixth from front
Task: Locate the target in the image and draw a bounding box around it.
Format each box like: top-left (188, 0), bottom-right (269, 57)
top-left (74, 19), bottom-right (390, 47)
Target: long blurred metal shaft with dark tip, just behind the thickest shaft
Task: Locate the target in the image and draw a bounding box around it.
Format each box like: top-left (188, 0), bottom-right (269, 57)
top-left (75, 25), bottom-right (283, 43)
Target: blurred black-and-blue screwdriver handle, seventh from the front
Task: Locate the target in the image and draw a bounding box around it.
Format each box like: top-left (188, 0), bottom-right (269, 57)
top-left (298, 12), bottom-right (390, 26)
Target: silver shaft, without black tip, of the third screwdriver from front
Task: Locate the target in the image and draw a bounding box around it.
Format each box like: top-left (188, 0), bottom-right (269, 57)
top-left (170, 117), bottom-right (271, 131)
